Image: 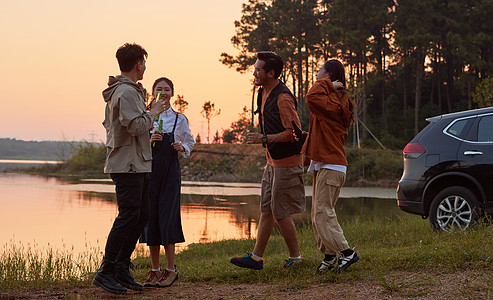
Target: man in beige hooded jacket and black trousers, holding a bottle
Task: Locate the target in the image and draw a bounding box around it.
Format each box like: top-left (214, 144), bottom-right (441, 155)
top-left (93, 43), bottom-right (164, 294)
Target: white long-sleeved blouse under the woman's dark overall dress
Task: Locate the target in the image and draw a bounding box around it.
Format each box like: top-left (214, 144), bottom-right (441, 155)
top-left (151, 107), bottom-right (195, 158)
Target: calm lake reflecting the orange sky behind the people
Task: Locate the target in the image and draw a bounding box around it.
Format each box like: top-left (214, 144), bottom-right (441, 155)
top-left (0, 173), bottom-right (403, 253)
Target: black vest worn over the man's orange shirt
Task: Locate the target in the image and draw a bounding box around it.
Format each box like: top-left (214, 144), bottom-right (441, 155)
top-left (256, 81), bottom-right (303, 159)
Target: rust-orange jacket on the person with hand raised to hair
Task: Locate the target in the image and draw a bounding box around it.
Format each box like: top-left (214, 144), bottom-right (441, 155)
top-left (301, 78), bottom-right (352, 166)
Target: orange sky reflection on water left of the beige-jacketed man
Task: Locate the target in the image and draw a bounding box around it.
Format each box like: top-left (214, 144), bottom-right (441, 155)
top-left (0, 174), bottom-right (116, 253)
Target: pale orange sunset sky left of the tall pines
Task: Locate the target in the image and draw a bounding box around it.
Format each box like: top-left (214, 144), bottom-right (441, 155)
top-left (0, 0), bottom-right (252, 142)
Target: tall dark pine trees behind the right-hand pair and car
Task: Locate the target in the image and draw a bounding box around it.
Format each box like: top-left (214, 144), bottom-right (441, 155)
top-left (220, 0), bottom-right (493, 148)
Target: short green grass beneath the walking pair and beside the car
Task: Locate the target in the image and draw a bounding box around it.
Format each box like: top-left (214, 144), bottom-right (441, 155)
top-left (137, 215), bottom-right (493, 286)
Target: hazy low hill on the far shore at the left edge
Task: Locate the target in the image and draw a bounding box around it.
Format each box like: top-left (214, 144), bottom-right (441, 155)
top-left (0, 138), bottom-right (87, 160)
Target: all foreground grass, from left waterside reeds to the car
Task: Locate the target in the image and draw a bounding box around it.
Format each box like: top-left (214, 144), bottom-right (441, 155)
top-left (0, 215), bottom-right (493, 294)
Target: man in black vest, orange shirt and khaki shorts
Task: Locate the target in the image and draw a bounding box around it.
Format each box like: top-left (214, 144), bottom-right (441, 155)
top-left (230, 52), bottom-right (306, 270)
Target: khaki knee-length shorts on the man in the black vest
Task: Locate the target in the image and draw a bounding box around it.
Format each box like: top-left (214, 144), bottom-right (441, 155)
top-left (260, 164), bottom-right (306, 220)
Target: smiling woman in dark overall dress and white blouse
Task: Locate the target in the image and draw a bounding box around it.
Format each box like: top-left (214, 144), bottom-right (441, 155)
top-left (140, 77), bottom-right (195, 287)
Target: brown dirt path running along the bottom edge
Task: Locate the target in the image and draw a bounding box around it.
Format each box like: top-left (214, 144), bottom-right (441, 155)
top-left (0, 270), bottom-right (493, 300)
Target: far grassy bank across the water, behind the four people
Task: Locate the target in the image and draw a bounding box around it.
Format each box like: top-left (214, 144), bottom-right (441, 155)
top-left (13, 143), bottom-right (403, 186)
